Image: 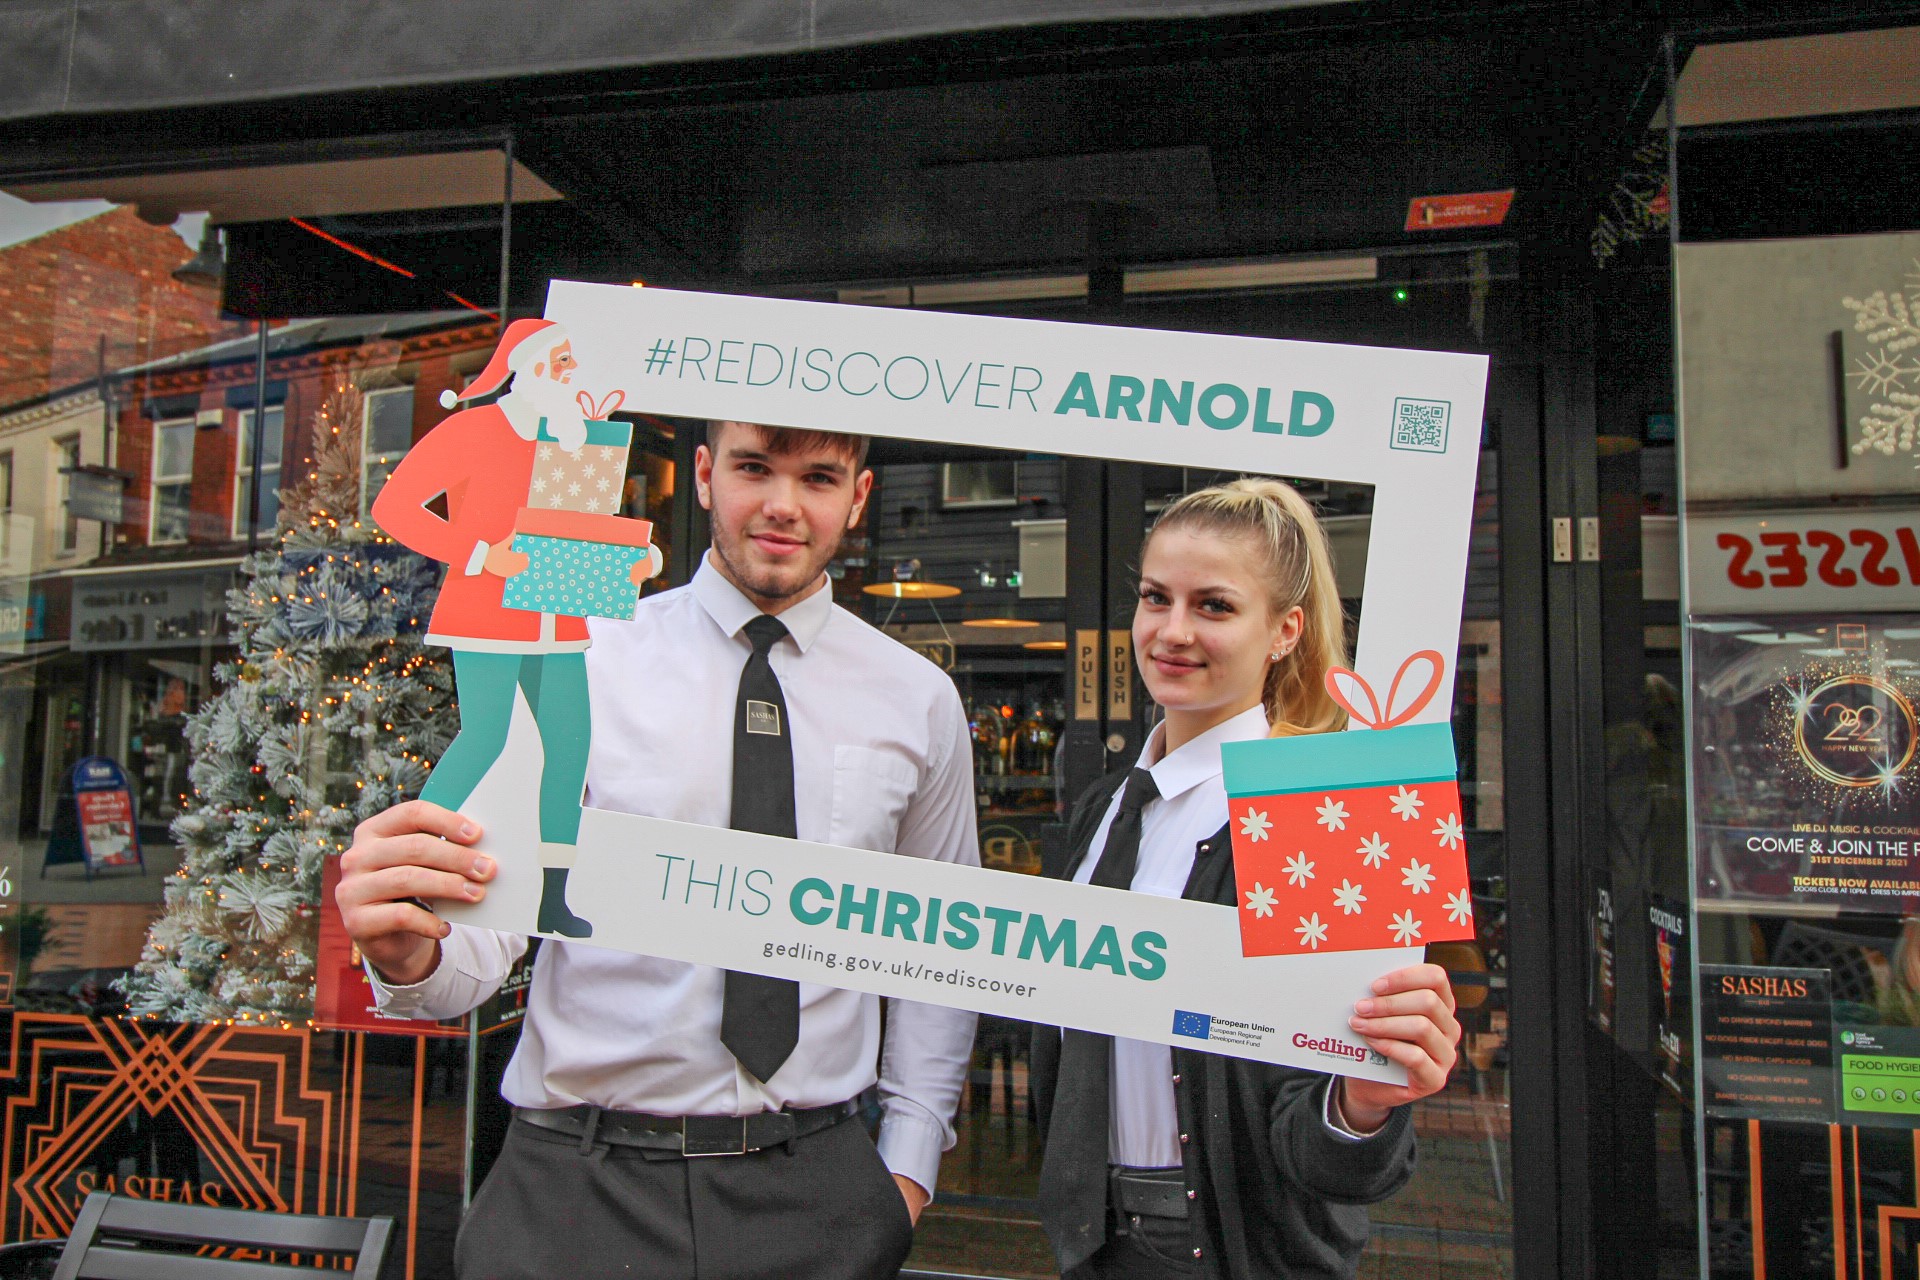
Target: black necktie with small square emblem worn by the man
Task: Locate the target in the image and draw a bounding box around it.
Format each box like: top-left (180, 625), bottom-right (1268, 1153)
top-left (720, 614), bottom-right (801, 1080)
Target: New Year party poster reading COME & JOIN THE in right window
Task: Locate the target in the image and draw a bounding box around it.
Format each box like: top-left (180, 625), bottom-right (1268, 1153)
top-left (1688, 612), bottom-right (1920, 913)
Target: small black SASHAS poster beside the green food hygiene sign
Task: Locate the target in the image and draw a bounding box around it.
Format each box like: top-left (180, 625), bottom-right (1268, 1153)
top-left (1699, 965), bottom-right (1834, 1125)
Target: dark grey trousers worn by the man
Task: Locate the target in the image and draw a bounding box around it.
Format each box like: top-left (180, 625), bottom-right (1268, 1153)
top-left (455, 1121), bottom-right (914, 1280)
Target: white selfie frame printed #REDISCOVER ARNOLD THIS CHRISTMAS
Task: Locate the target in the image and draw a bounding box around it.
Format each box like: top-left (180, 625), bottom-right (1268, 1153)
top-left (442, 280), bottom-right (1486, 1080)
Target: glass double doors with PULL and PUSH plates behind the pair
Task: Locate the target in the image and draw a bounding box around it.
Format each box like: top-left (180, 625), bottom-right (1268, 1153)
top-left (883, 253), bottom-right (1538, 1278)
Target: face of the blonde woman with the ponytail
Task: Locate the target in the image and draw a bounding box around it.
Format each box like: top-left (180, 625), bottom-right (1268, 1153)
top-left (1133, 528), bottom-right (1302, 725)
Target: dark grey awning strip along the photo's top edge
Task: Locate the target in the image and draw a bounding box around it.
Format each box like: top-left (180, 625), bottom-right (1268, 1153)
top-left (0, 0), bottom-right (1334, 119)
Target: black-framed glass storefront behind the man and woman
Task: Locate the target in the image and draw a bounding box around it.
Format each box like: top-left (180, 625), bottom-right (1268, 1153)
top-left (0, 4), bottom-right (1920, 1280)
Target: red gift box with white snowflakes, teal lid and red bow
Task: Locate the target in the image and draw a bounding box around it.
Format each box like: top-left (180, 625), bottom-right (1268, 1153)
top-left (1221, 652), bottom-right (1473, 956)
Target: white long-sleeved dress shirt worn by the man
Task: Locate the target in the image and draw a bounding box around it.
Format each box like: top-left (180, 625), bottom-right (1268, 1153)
top-left (374, 562), bottom-right (979, 1192)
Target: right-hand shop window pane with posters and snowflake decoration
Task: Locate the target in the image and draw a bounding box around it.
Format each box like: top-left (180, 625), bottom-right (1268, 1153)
top-left (1672, 29), bottom-right (1920, 1280)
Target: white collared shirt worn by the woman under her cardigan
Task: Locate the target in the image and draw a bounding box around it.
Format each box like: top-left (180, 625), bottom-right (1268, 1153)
top-left (1073, 706), bottom-right (1361, 1169)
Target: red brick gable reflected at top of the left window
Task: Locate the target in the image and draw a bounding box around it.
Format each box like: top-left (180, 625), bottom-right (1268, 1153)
top-left (0, 209), bottom-right (248, 407)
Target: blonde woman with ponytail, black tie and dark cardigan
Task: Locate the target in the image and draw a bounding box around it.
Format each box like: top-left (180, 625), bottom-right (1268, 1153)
top-left (1031, 480), bottom-right (1459, 1280)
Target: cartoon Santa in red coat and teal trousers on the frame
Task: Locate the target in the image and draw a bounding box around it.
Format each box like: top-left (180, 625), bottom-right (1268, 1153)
top-left (372, 319), bottom-right (664, 938)
